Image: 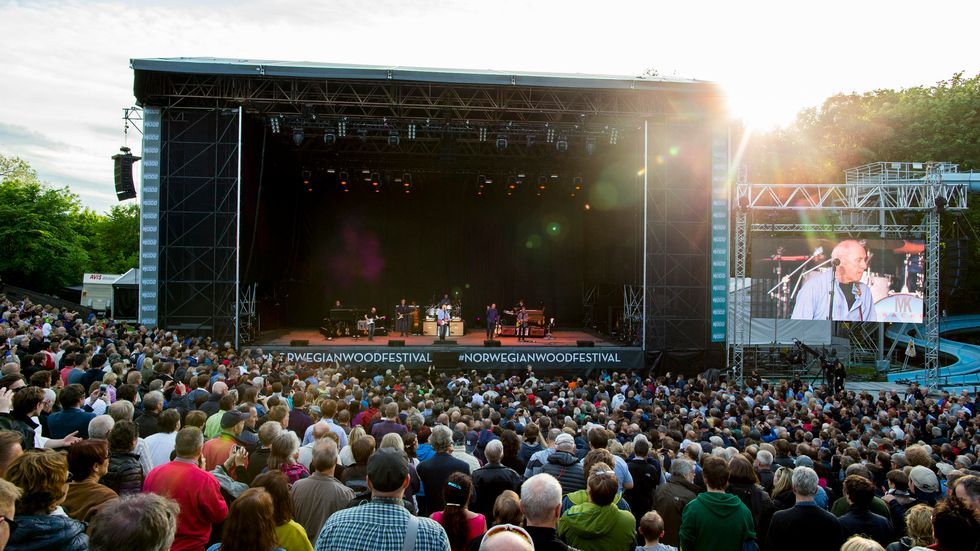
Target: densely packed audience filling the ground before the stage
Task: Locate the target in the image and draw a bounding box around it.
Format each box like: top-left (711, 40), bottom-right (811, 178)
top-left (0, 296), bottom-right (980, 551)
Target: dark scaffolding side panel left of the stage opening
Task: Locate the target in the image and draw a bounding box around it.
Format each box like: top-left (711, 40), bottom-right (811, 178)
top-left (158, 108), bottom-right (240, 340)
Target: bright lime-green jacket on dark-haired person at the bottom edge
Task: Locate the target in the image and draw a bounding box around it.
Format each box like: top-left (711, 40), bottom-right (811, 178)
top-left (558, 492), bottom-right (636, 551)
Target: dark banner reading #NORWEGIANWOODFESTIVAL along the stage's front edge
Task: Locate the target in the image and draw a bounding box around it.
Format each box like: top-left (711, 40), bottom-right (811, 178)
top-left (262, 346), bottom-right (644, 371)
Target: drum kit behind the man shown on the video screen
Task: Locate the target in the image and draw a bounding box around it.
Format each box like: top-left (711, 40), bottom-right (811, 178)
top-left (764, 241), bottom-right (925, 322)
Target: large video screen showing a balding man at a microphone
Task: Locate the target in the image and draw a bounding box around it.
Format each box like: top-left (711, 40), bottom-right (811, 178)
top-left (750, 237), bottom-right (925, 323)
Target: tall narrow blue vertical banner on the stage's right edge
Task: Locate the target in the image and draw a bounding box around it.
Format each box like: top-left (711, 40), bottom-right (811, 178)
top-left (711, 129), bottom-right (729, 342)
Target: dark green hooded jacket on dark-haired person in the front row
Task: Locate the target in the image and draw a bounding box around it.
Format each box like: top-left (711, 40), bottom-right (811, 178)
top-left (680, 492), bottom-right (756, 551)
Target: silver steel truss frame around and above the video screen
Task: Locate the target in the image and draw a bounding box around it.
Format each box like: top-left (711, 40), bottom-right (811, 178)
top-left (729, 162), bottom-right (970, 386)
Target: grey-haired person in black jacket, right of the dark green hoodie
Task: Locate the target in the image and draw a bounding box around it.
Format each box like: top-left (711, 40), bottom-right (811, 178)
top-left (766, 467), bottom-right (844, 551)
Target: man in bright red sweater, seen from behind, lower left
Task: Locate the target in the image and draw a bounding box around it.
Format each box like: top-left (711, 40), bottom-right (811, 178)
top-left (143, 427), bottom-right (228, 551)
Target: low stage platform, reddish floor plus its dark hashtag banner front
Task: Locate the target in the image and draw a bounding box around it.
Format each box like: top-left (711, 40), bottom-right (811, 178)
top-left (254, 329), bottom-right (644, 374)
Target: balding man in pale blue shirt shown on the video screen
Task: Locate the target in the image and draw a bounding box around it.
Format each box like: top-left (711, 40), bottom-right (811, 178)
top-left (791, 239), bottom-right (877, 321)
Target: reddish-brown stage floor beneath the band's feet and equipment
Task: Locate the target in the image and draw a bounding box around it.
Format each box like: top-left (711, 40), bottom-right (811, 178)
top-left (253, 328), bottom-right (622, 348)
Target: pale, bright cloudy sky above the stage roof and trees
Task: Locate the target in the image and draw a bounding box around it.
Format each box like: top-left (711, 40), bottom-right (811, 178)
top-left (0, 0), bottom-right (980, 211)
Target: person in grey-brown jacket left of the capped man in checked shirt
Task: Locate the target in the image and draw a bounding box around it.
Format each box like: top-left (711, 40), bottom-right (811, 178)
top-left (292, 438), bottom-right (354, 542)
